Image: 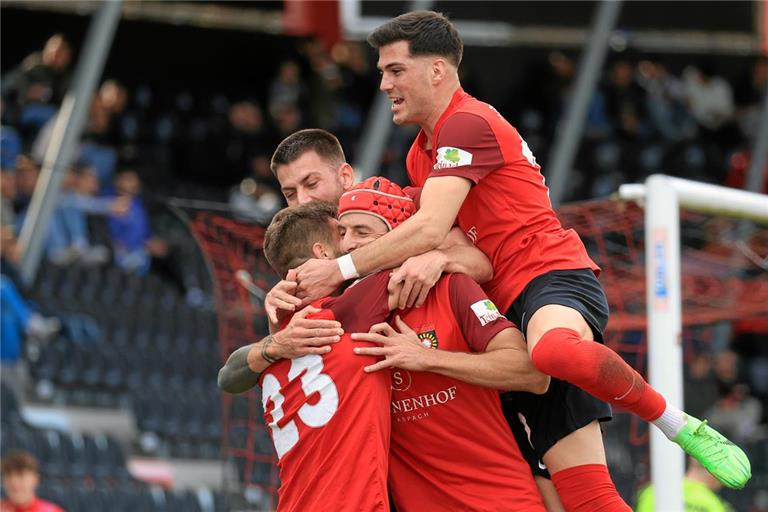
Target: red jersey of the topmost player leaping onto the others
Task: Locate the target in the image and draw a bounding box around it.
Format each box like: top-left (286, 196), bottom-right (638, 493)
top-left (406, 88), bottom-right (600, 311)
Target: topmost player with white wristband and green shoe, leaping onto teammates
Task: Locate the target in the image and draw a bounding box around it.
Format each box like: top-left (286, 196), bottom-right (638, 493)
top-left (297, 11), bottom-right (751, 511)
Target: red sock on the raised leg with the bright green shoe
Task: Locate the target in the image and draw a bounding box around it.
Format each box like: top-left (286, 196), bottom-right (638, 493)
top-left (531, 328), bottom-right (667, 421)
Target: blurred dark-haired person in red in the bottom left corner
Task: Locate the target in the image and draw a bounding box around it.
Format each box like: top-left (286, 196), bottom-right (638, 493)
top-left (0, 450), bottom-right (64, 512)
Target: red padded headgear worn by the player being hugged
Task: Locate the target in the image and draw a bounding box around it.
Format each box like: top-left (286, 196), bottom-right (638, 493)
top-left (339, 176), bottom-right (416, 231)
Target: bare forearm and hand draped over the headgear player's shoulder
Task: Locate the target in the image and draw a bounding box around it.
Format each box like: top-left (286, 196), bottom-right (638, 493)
top-left (389, 227), bottom-right (493, 309)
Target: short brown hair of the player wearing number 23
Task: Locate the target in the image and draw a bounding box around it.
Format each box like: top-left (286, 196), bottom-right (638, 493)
top-left (264, 201), bottom-right (336, 277)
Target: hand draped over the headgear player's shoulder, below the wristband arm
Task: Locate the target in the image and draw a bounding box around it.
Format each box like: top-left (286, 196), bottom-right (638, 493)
top-left (388, 250), bottom-right (447, 309)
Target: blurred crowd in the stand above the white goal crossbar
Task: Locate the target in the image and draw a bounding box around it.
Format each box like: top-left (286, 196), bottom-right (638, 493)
top-left (506, 52), bottom-right (768, 200)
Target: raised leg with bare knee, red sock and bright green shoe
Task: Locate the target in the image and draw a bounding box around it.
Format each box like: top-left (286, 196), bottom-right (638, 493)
top-left (526, 270), bottom-right (751, 489)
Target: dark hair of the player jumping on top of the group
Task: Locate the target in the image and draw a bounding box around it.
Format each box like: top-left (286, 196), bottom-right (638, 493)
top-left (368, 11), bottom-right (464, 67)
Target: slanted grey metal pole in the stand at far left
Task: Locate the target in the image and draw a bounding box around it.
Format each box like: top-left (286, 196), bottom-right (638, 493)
top-left (19, 0), bottom-right (122, 285)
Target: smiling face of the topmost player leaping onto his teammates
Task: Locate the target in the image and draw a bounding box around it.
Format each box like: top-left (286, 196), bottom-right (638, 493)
top-left (377, 41), bottom-right (434, 124)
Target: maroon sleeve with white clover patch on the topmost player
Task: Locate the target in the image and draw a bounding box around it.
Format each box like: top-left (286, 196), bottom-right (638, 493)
top-left (436, 112), bottom-right (504, 185)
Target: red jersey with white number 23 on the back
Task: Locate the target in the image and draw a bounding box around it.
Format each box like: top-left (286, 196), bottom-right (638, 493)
top-left (260, 272), bottom-right (391, 512)
